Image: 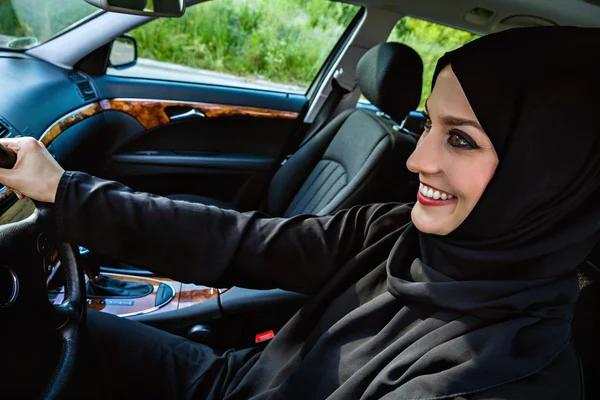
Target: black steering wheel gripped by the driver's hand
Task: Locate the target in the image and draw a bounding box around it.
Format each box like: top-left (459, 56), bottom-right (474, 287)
top-left (0, 148), bottom-right (86, 399)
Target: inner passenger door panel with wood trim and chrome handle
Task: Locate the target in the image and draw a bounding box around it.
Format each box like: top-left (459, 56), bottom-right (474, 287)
top-left (85, 76), bottom-right (307, 209)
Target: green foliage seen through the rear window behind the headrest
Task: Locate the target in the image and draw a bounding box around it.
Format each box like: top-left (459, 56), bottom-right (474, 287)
top-left (388, 17), bottom-right (479, 109)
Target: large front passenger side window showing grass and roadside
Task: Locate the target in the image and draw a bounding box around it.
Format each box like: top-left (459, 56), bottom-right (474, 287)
top-left (107, 0), bottom-right (360, 94)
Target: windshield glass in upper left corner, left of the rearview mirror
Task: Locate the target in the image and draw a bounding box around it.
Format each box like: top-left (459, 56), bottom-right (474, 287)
top-left (0, 0), bottom-right (99, 50)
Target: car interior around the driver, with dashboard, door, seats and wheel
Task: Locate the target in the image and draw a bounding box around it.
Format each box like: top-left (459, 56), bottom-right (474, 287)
top-left (0, 0), bottom-right (600, 399)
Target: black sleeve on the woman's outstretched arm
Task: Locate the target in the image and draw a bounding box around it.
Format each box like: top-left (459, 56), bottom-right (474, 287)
top-left (56, 172), bottom-right (408, 293)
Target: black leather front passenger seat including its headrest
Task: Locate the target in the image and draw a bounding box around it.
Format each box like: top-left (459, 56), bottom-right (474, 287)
top-left (169, 43), bottom-right (423, 217)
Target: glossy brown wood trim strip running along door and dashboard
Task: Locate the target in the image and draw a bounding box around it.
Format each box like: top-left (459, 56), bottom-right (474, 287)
top-left (40, 99), bottom-right (299, 147)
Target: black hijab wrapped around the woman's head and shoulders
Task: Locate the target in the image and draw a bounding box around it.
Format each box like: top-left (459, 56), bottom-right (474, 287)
top-left (387, 27), bottom-right (600, 398)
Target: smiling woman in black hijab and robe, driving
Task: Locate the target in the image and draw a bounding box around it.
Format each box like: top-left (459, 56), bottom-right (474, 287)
top-left (0, 27), bottom-right (600, 399)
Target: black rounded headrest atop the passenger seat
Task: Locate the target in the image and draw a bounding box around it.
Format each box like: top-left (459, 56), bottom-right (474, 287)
top-left (356, 43), bottom-right (423, 122)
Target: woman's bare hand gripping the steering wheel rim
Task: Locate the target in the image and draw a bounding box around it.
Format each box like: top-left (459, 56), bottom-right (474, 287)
top-left (0, 137), bottom-right (65, 203)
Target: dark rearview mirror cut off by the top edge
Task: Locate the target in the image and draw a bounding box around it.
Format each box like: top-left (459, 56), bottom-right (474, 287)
top-left (85, 0), bottom-right (185, 17)
